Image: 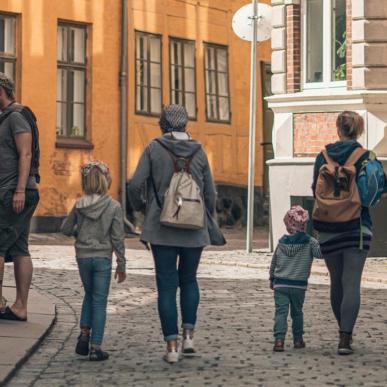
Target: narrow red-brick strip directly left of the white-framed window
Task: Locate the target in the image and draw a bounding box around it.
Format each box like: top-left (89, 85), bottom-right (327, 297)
top-left (286, 4), bottom-right (301, 93)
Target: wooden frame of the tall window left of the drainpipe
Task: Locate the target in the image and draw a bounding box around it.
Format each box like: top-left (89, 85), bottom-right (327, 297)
top-left (56, 20), bottom-right (89, 139)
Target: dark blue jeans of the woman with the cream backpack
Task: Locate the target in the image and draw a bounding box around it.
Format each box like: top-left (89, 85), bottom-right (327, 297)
top-left (152, 245), bottom-right (203, 341)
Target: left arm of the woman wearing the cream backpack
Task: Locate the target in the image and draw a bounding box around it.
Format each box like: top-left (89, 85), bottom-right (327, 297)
top-left (128, 147), bottom-right (151, 211)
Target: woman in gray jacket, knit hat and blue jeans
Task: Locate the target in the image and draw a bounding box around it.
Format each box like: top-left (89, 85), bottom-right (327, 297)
top-left (128, 105), bottom-right (216, 363)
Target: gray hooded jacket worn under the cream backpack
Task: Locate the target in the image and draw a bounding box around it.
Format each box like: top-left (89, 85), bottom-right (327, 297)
top-left (128, 133), bottom-right (216, 247)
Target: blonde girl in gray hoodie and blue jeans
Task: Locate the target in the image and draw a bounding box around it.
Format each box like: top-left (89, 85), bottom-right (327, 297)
top-left (62, 161), bottom-right (126, 361)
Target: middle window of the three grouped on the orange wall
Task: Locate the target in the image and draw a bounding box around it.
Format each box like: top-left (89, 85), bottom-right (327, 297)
top-left (169, 38), bottom-right (196, 119)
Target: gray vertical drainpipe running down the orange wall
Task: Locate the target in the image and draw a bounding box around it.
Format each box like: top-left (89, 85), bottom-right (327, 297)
top-left (120, 0), bottom-right (135, 233)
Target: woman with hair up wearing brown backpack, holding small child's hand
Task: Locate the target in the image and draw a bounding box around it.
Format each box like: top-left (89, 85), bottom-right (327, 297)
top-left (312, 111), bottom-right (384, 355)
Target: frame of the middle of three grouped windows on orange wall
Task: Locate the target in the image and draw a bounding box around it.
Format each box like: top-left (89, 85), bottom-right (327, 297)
top-left (169, 36), bottom-right (198, 121)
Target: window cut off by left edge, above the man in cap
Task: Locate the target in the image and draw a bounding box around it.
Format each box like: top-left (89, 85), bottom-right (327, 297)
top-left (0, 14), bottom-right (16, 80)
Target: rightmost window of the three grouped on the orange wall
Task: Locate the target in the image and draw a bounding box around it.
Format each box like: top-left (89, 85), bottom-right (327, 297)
top-left (204, 44), bottom-right (231, 123)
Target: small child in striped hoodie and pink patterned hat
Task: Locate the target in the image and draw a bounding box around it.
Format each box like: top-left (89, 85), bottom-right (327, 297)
top-left (270, 206), bottom-right (322, 352)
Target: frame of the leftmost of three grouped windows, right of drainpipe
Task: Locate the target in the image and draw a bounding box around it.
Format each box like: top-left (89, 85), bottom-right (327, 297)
top-left (134, 30), bottom-right (164, 117)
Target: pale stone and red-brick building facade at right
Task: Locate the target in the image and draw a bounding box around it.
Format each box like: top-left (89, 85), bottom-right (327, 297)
top-left (268, 0), bottom-right (387, 255)
